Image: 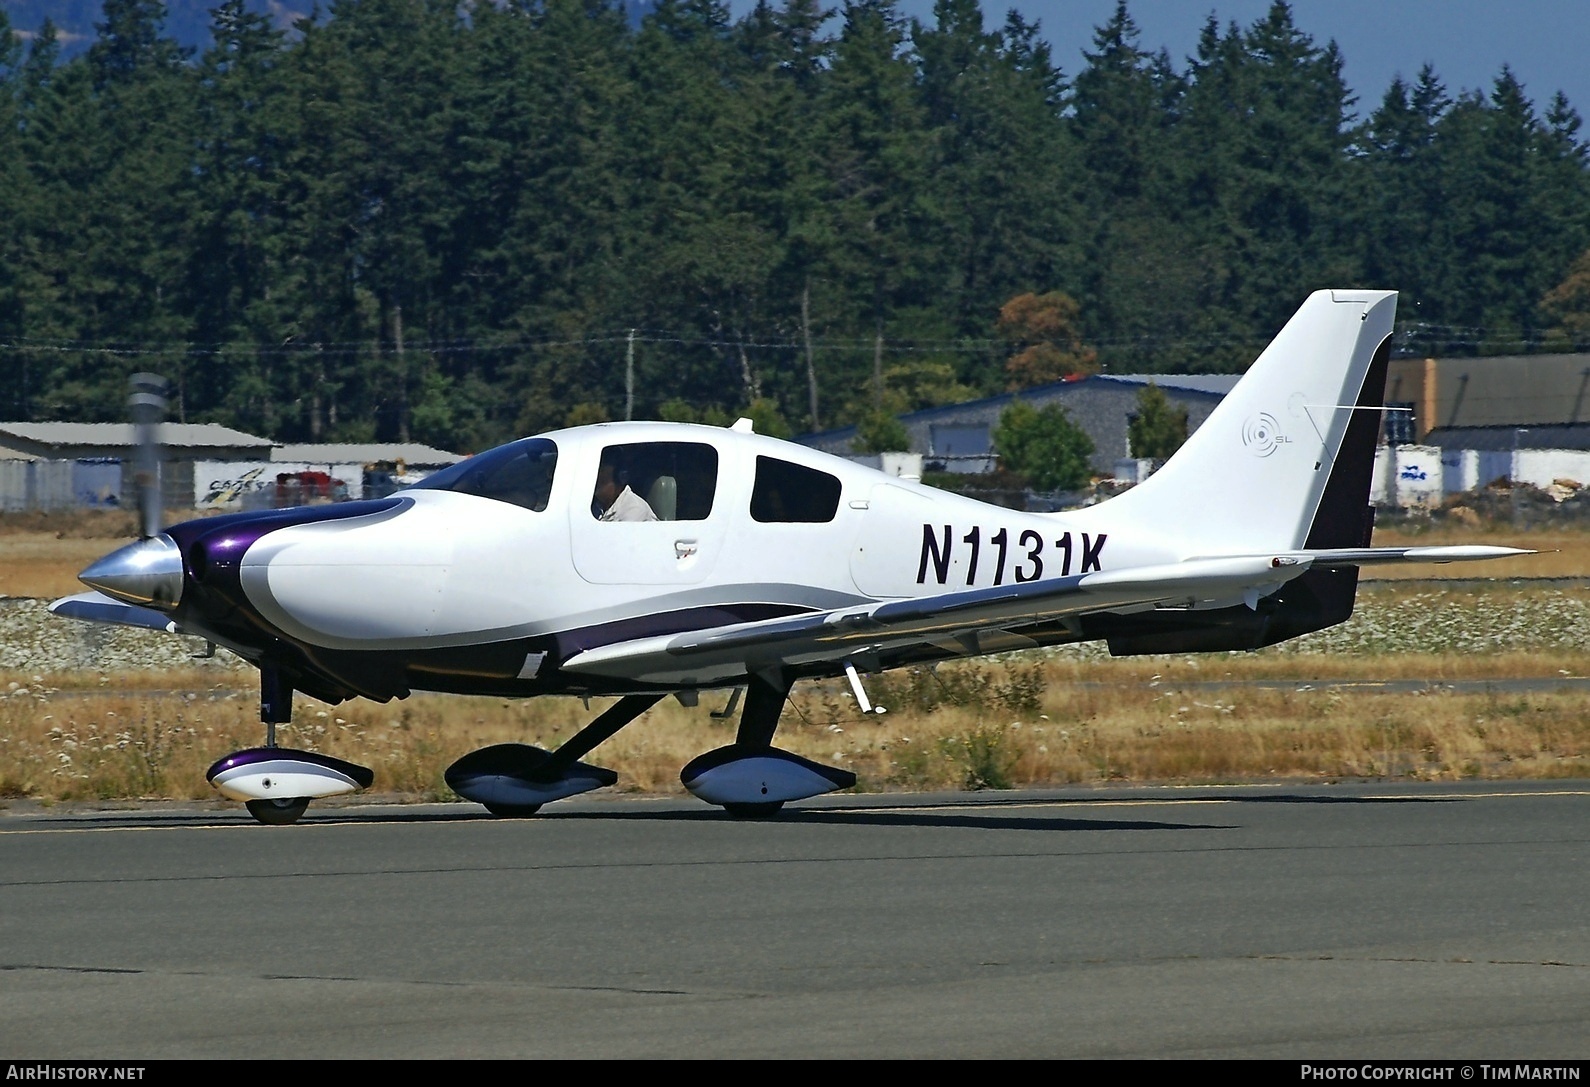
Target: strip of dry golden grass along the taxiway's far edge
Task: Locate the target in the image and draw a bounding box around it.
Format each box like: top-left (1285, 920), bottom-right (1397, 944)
top-left (0, 656), bottom-right (1590, 799)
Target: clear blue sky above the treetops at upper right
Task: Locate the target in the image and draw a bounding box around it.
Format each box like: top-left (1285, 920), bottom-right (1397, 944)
top-left (731, 0), bottom-right (1590, 114)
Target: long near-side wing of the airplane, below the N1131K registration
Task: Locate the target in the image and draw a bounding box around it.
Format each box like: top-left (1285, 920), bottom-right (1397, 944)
top-left (563, 555), bottom-right (1310, 683)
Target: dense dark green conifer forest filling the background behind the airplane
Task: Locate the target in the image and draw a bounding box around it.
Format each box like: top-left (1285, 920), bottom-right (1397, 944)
top-left (0, 0), bottom-right (1590, 451)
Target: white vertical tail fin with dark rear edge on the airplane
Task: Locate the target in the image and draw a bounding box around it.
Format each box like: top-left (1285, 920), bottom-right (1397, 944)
top-left (1110, 291), bottom-right (1396, 556)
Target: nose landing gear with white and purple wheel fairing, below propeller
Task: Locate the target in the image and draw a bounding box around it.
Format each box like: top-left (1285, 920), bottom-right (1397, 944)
top-left (207, 664), bottom-right (375, 826)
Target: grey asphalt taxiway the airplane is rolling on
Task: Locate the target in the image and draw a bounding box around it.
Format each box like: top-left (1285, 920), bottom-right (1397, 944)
top-left (0, 782), bottom-right (1590, 1060)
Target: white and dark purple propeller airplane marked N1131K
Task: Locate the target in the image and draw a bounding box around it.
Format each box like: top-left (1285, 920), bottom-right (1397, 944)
top-left (52, 291), bottom-right (1526, 823)
